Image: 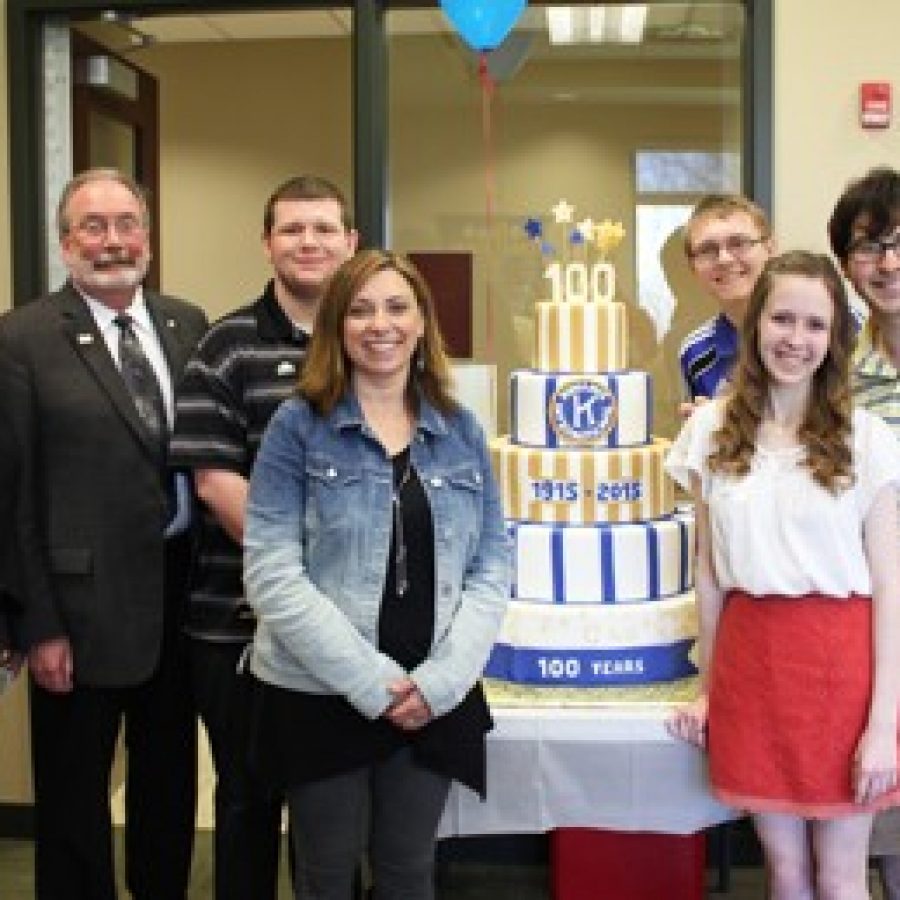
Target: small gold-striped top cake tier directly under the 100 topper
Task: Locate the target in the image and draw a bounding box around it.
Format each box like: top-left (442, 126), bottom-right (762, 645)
top-left (535, 300), bottom-right (628, 372)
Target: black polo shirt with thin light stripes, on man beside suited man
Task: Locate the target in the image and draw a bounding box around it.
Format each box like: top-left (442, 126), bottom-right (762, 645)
top-left (169, 281), bottom-right (309, 642)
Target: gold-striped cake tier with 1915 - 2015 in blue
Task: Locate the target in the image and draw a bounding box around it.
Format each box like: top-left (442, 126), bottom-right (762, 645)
top-left (491, 436), bottom-right (675, 525)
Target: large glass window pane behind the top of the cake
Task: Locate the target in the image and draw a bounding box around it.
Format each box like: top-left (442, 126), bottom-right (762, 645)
top-left (388, 3), bottom-right (744, 434)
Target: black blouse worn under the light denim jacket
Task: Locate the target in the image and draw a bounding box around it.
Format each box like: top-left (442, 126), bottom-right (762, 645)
top-left (248, 448), bottom-right (493, 796)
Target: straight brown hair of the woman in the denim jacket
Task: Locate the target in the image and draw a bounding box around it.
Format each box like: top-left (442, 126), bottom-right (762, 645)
top-left (299, 249), bottom-right (459, 415)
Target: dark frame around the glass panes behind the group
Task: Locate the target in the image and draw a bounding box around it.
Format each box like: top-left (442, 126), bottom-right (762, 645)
top-left (7, 0), bottom-right (772, 304)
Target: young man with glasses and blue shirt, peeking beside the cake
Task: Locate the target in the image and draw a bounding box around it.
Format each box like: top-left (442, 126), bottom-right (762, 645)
top-left (678, 194), bottom-right (774, 406)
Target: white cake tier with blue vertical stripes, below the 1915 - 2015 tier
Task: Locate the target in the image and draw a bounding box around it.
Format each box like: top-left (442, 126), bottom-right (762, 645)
top-left (509, 513), bottom-right (694, 604)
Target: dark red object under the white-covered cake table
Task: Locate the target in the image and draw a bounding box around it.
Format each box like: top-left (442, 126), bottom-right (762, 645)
top-left (550, 828), bottom-right (706, 900)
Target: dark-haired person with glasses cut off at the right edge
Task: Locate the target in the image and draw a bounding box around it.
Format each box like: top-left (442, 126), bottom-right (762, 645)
top-left (828, 168), bottom-right (900, 900)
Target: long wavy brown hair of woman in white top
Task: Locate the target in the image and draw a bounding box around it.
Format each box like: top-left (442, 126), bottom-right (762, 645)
top-left (709, 251), bottom-right (854, 493)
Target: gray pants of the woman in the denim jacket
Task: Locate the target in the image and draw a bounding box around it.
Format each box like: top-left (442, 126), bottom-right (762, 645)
top-left (287, 749), bottom-right (450, 900)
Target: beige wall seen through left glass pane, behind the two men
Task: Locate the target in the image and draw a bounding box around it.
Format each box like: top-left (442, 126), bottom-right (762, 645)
top-left (134, 40), bottom-right (352, 316)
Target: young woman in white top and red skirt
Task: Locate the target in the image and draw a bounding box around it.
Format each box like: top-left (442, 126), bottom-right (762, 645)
top-left (668, 252), bottom-right (900, 900)
